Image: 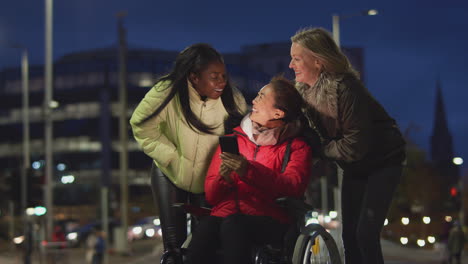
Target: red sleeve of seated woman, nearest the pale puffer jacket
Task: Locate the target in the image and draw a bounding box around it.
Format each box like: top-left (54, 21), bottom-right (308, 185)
top-left (205, 146), bottom-right (234, 206)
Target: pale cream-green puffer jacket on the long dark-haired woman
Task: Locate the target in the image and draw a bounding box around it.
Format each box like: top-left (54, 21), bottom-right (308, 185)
top-left (130, 81), bottom-right (247, 193)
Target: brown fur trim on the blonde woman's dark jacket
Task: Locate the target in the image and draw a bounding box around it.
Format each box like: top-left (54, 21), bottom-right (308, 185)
top-left (296, 72), bottom-right (345, 119)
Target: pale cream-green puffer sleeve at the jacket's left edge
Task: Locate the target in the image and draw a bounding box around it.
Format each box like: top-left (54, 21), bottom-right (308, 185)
top-left (130, 82), bottom-right (177, 167)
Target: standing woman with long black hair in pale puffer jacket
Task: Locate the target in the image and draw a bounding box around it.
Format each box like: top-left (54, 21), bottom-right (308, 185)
top-left (130, 43), bottom-right (247, 262)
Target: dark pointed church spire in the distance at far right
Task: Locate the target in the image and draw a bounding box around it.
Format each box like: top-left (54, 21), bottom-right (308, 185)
top-left (431, 79), bottom-right (453, 162)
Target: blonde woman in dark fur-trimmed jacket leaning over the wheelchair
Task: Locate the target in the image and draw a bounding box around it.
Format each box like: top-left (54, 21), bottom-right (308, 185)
top-left (289, 28), bottom-right (405, 264)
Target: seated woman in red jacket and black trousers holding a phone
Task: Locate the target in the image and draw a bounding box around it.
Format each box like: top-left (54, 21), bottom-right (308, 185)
top-left (188, 77), bottom-right (311, 264)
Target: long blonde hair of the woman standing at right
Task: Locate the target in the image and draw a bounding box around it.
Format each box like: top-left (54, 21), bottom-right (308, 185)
top-left (291, 28), bottom-right (358, 77)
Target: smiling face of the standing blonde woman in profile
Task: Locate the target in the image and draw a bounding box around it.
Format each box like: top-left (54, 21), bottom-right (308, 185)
top-left (289, 42), bottom-right (322, 86)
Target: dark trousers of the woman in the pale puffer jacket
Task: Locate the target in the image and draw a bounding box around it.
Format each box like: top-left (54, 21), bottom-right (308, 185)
top-left (151, 164), bottom-right (206, 253)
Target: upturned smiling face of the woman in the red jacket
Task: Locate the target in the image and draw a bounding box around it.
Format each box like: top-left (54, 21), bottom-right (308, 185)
top-left (250, 84), bottom-right (284, 127)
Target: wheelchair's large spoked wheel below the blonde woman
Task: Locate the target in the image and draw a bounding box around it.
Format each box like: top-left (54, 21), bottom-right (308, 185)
top-left (292, 224), bottom-right (342, 264)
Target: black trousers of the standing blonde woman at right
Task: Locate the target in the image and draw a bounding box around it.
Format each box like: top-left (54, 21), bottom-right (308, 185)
top-left (341, 166), bottom-right (402, 264)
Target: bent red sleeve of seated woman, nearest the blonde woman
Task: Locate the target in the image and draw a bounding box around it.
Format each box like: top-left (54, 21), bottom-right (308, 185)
top-left (236, 141), bottom-right (312, 197)
